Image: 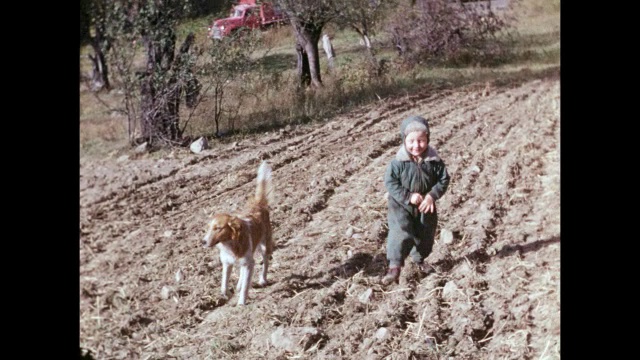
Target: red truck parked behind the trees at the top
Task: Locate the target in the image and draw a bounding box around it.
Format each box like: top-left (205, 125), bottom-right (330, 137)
top-left (208, 0), bottom-right (287, 39)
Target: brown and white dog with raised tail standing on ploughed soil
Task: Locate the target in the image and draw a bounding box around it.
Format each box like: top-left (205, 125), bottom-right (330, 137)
top-left (202, 161), bottom-right (273, 305)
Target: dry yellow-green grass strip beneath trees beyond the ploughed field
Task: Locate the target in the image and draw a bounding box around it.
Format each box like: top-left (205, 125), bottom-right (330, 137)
top-left (80, 0), bottom-right (560, 158)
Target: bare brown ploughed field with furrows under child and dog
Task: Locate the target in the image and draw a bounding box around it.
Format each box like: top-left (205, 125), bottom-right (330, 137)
top-left (79, 70), bottom-right (560, 359)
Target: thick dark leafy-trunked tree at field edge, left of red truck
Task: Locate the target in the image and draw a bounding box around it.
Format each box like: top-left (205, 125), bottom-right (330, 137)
top-left (108, 0), bottom-right (200, 144)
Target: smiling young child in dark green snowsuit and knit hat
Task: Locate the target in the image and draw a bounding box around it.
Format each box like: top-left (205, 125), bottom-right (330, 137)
top-left (382, 116), bottom-right (449, 285)
